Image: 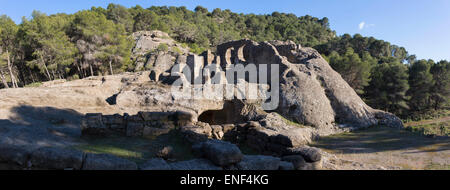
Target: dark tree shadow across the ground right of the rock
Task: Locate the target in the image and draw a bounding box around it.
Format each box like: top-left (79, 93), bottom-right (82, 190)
top-left (312, 127), bottom-right (450, 154)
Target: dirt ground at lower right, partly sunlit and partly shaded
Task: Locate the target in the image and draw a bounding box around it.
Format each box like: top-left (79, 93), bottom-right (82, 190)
top-left (311, 127), bottom-right (450, 170)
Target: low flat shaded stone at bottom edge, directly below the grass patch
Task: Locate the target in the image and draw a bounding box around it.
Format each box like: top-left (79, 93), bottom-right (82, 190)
top-left (82, 154), bottom-right (137, 170)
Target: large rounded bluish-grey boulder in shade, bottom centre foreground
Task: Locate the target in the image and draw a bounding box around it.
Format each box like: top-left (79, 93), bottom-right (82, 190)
top-left (198, 140), bottom-right (243, 166)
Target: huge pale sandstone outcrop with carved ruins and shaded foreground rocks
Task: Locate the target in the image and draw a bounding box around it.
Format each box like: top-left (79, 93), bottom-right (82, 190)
top-left (0, 31), bottom-right (403, 170)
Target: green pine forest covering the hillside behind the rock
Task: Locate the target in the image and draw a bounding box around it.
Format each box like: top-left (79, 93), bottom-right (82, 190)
top-left (0, 4), bottom-right (450, 117)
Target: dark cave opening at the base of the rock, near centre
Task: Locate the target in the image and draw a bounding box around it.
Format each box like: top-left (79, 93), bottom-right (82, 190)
top-left (198, 101), bottom-right (244, 125)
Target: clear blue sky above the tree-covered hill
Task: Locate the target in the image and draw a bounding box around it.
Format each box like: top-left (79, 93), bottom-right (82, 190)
top-left (0, 0), bottom-right (450, 60)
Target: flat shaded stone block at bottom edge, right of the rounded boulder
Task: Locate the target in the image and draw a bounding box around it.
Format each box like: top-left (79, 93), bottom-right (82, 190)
top-left (236, 156), bottom-right (280, 170)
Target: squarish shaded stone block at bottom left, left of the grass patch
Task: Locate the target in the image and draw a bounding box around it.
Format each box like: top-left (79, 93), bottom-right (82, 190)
top-left (30, 147), bottom-right (84, 170)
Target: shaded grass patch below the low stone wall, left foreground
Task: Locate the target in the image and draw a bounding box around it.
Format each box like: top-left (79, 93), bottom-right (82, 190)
top-left (74, 132), bottom-right (194, 164)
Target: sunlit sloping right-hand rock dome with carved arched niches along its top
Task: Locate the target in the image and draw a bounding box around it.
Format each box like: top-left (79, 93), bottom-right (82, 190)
top-left (213, 40), bottom-right (401, 135)
